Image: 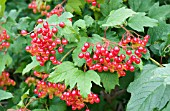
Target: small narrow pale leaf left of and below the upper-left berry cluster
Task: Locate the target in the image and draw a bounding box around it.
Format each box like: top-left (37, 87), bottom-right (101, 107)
top-left (22, 56), bottom-right (39, 75)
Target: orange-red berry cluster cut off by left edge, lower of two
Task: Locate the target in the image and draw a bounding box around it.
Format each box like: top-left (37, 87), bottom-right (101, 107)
top-left (0, 71), bottom-right (16, 90)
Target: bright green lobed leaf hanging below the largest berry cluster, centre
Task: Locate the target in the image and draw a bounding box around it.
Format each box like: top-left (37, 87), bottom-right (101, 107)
top-left (48, 61), bottom-right (100, 97)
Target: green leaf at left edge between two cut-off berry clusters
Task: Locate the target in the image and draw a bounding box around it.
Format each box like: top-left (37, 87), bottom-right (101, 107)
top-left (0, 53), bottom-right (12, 75)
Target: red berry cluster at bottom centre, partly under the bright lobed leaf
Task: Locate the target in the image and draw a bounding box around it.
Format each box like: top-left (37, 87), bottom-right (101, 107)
top-left (60, 90), bottom-right (100, 111)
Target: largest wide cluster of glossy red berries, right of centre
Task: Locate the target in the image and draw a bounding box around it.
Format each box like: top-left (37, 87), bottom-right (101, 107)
top-left (79, 35), bottom-right (149, 76)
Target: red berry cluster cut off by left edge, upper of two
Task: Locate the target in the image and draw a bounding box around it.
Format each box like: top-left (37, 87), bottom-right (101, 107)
top-left (0, 30), bottom-right (10, 50)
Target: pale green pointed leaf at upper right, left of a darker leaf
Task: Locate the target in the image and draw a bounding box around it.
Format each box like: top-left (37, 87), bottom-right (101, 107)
top-left (102, 7), bottom-right (136, 26)
